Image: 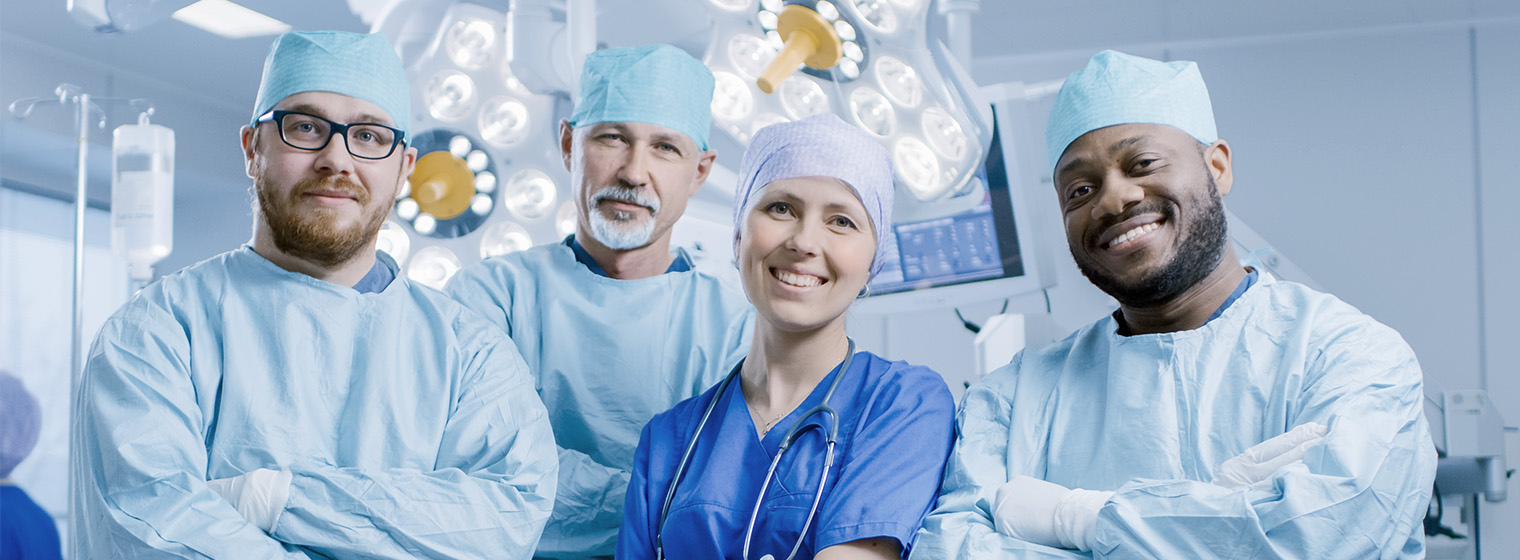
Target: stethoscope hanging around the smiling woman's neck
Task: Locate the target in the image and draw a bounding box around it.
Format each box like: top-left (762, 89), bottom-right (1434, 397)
top-left (655, 339), bottom-right (854, 560)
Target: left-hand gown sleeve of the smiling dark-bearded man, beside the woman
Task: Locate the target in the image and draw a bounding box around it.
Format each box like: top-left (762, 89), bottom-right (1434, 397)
top-left (909, 371), bottom-right (1090, 560)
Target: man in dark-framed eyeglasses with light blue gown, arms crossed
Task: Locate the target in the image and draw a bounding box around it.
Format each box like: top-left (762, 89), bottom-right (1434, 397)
top-left (70, 32), bottom-right (558, 558)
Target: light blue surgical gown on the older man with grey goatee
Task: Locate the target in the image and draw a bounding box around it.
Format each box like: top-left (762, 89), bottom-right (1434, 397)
top-left (447, 238), bottom-right (754, 557)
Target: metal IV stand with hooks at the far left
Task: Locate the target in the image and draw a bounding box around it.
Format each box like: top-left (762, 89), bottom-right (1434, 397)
top-left (11, 84), bottom-right (154, 398)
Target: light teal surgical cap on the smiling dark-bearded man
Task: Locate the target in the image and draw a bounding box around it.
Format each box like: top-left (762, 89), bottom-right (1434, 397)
top-left (1046, 50), bottom-right (1219, 170)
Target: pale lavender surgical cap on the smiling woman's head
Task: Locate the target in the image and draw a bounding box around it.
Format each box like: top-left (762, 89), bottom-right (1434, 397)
top-left (734, 113), bottom-right (892, 278)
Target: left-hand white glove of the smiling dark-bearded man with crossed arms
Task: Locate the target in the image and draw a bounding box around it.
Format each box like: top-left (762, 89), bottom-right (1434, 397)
top-left (993, 475), bottom-right (1114, 551)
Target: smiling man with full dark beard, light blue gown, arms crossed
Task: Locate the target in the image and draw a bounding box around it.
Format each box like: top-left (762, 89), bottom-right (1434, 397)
top-left (912, 52), bottom-right (1435, 560)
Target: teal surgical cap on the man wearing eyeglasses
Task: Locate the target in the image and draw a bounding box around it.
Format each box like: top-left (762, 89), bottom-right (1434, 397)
top-left (252, 30), bottom-right (412, 131)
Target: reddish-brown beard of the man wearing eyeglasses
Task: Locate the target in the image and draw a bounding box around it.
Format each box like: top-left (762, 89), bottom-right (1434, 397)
top-left (254, 175), bottom-right (389, 268)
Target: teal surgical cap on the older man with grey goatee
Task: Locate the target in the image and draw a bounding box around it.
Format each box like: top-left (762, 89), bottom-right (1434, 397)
top-left (570, 44), bottom-right (713, 151)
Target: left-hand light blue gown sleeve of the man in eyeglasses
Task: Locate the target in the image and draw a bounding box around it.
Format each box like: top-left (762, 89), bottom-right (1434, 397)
top-left (70, 301), bottom-right (320, 558)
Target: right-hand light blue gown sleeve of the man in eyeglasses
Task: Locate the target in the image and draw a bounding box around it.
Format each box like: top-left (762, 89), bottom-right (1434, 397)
top-left (271, 310), bottom-right (558, 558)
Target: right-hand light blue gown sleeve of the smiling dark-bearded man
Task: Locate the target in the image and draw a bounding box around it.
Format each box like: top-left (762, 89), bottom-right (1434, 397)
top-left (1093, 312), bottom-right (1435, 558)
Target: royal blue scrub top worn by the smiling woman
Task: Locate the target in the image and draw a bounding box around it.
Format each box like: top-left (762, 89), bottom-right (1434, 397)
top-left (617, 352), bottom-right (955, 560)
